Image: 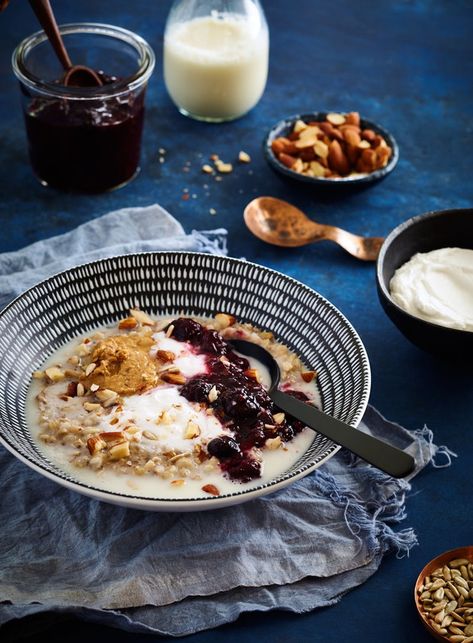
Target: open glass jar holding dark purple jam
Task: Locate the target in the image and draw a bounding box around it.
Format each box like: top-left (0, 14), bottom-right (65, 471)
top-left (12, 23), bottom-right (155, 192)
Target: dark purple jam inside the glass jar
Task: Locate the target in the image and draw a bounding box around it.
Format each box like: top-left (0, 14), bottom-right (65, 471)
top-left (25, 72), bottom-right (144, 192)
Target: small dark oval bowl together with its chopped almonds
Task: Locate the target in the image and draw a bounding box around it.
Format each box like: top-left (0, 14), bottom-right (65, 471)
top-left (263, 112), bottom-right (399, 187)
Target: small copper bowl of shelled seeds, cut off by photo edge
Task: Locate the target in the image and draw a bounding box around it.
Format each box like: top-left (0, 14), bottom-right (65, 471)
top-left (414, 546), bottom-right (473, 643)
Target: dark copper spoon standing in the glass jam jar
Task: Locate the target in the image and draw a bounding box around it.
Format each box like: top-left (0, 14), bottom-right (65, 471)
top-left (29, 0), bottom-right (103, 87)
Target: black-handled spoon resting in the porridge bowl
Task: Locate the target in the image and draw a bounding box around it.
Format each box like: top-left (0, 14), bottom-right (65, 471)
top-left (227, 339), bottom-right (415, 478)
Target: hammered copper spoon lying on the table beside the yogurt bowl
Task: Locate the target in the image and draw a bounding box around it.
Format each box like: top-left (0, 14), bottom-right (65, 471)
top-left (243, 196), bottom-right (384, 261)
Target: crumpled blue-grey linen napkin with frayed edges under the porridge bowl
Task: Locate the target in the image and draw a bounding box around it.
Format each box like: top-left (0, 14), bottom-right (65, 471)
top-left (0, 205), bottom-right (454, 636)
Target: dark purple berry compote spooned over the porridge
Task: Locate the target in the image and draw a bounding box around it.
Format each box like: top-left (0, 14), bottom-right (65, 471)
top-left (168, 318), bottom-right (308, 482)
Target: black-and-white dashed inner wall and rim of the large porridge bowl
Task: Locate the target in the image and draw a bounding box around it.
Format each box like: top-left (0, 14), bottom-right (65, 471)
top-left (0, 252), bottom-right (370, 505)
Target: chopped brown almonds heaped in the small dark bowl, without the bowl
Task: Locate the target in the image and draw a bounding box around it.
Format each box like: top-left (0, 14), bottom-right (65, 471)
top-left (271, 112), bottom-right (392, 179)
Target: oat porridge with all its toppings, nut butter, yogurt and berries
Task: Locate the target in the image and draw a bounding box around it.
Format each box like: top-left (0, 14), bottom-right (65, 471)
top-left (27, 310), bottom-right (320, 498)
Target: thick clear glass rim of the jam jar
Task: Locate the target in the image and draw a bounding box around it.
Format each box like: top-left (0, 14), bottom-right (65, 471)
top-left (12, 22), bottom-right (156, 100)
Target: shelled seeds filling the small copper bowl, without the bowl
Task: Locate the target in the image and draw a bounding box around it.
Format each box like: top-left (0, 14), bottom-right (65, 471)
top-left (417, 558), bottom-right (473, 643)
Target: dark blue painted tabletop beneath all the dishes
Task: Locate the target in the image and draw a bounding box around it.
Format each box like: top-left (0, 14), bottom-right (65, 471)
top-left (0, 0), bottom-right (473, 643)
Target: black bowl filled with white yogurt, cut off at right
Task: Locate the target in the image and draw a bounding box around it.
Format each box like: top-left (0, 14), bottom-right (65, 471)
top-left (376, 208), bottom-right (473, 358)
